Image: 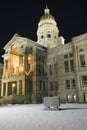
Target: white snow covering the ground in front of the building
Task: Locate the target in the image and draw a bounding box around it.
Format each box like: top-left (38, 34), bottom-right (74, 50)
top-left (0, 104), bottom-right (87, 130)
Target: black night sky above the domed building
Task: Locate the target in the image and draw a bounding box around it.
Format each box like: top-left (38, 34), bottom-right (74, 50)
top-left (0, 0), bottom-right (87, 62)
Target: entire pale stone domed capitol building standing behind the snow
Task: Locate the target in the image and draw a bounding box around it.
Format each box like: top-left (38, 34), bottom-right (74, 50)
top-left (0, 7), bottom-right (87, 103)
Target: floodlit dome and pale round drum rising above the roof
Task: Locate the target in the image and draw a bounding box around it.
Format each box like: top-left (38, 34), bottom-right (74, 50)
top-left (37, 6), bottom-right (59, 48)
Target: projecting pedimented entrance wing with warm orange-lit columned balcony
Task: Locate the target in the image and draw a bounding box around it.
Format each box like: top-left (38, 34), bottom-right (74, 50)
top-left (1, 34), bottom-right (47, 103)
